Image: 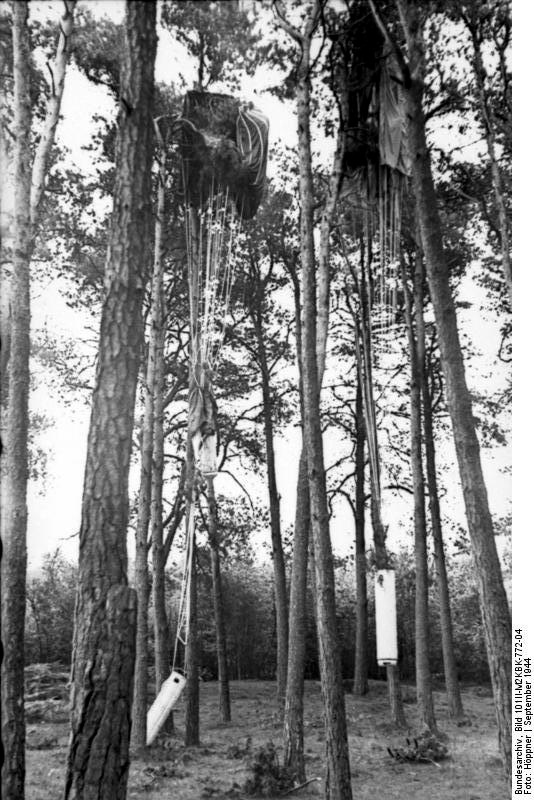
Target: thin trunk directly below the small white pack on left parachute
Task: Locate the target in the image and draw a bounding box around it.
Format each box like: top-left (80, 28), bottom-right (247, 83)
top-left (206, 476), bottom-right (232, 722)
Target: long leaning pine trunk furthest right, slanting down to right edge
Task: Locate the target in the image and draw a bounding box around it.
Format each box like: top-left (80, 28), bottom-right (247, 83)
top-left (407, 12), bottom-right (512, 778)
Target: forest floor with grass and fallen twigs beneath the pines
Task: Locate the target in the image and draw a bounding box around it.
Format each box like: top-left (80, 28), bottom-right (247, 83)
top-left (26, 681), bottom-right (507, 800)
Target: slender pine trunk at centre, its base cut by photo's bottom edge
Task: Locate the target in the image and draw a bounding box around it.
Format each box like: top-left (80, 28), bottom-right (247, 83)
top-left (296, 18), bottom-right (352, 800)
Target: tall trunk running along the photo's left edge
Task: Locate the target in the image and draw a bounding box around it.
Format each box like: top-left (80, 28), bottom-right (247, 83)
top-left (1, 2), bottom-right (32, 800)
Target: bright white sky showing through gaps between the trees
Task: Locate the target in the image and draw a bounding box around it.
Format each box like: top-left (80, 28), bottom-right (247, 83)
top-left (18, 0), bottom-right (516, 580)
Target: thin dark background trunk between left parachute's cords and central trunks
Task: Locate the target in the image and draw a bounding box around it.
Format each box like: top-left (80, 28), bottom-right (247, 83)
top-left (252, 304), bottom-right (289, 706)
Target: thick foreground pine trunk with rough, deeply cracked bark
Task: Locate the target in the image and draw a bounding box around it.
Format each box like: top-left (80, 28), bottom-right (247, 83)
top-left (65, 7), bottom-right (156, 800)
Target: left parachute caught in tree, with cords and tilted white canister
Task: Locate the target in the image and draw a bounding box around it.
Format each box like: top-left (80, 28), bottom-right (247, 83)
top-left (147, 91), bottom-right (269, 745)
